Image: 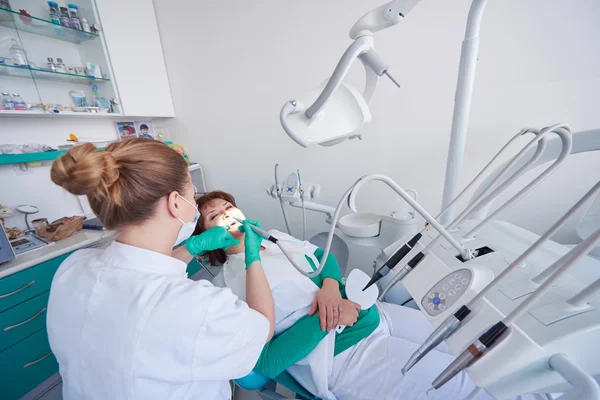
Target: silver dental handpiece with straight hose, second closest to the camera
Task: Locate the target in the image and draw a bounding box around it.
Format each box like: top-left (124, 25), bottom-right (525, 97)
top-left (402, 182), bottom-right (600, 374)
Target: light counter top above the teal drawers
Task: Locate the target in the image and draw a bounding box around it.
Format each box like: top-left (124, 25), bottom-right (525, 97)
top-left (0, 229), bottom-right (115, 279)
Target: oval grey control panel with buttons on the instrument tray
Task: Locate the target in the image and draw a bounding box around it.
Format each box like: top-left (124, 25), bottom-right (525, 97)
top-left (421, 269), bottom-right (473, 317)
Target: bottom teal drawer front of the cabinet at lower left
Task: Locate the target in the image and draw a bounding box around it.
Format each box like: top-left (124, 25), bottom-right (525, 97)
top-left (0, 329), bottom-right (58, 400)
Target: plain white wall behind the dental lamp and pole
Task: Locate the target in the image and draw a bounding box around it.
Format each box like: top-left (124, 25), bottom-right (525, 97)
top-left (154, 0), bottom-right (600, 272)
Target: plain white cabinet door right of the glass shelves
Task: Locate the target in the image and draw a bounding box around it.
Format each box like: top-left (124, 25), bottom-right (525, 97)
top-left (96, 0), bottom-right (175, 117)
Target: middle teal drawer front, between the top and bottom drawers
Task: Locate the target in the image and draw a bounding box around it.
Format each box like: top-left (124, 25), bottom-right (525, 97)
top-left (0, 292), bottom-right (50, 351)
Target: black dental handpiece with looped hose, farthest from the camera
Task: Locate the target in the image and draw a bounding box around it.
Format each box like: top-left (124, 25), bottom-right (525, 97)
top-left (366, 124), bottom-right (546, 290)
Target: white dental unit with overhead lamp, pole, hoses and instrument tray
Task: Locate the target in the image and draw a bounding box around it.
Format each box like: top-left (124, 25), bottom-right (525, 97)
top-left (269, 0), bottom-right (600, 400)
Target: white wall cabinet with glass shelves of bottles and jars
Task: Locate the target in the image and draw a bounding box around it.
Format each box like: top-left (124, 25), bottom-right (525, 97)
top-left (0, 0), bottom-right (174, 117)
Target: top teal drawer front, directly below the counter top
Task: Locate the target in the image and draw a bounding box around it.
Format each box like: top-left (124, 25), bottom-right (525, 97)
top-left (0, 253), bottom-right (71, 312)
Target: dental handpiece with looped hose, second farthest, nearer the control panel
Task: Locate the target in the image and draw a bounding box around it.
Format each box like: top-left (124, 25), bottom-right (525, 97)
top-left (379, 124), bottom-right (573, 299)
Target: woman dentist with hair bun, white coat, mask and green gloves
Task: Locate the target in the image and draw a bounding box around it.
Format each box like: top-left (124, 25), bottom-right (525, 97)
top-left (47, 138), bottom-right (275, 400)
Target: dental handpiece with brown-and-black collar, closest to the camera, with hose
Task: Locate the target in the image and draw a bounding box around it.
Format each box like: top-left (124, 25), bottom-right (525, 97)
top-left (432, 229), bottom-right (600, 389)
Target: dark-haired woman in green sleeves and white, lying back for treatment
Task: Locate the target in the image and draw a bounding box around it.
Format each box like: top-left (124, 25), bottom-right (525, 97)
top-left (195, 191), bottom-right (548, 400)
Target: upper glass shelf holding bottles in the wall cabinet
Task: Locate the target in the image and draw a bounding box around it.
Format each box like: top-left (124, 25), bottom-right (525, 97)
top-left (0, 8), bottom-right (98, 43)
